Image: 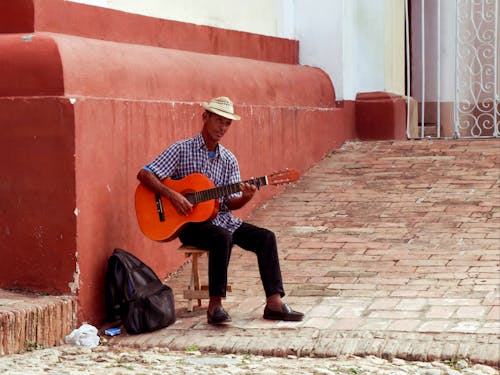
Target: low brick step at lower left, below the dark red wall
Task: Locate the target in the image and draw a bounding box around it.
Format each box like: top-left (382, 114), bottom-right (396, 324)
top-left (0, 289), bottom-right (76, 355)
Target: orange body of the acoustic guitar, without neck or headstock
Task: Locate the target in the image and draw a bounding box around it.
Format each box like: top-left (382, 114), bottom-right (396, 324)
top-left (135, 173), bottom-right (219, 242)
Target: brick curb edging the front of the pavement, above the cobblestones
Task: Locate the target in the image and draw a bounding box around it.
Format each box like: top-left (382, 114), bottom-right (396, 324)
top-left (112, 327), bottom-right (500, 366)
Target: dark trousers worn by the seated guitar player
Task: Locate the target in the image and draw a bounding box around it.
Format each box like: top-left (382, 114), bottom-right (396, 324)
top-left (179, 221), bottom-right (285, 297)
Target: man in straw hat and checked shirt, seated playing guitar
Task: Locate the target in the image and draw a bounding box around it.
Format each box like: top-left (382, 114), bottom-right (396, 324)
top-left (137, 97), bottom-right (304, 324)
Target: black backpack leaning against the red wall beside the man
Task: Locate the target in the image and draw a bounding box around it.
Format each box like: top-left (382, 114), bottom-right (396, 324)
top-left (105, 249), bottom-right (175, 333)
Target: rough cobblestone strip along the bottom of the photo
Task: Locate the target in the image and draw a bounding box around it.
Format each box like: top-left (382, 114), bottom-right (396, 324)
top-left (0, 345), bottom-right (499, 375)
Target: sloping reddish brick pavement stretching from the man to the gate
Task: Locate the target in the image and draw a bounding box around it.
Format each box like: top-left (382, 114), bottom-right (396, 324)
top-left (112, 140), bottom-right (500, 366)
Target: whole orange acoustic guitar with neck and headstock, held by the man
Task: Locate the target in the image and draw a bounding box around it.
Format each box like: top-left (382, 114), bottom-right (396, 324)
top-left (135, 169), bottom-right (299, 242)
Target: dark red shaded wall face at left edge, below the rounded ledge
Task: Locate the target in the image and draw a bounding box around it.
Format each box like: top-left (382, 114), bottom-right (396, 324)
top-left (0, 97), bottom-right (76, 293)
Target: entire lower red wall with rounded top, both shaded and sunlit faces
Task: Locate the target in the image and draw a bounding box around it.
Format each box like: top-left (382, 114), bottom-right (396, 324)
top-left (0, 1), bottom-right (354, 324)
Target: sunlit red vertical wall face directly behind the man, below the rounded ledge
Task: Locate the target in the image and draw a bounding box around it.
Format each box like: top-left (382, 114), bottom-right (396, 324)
top-left (75, 99), bottom-right (353, 326)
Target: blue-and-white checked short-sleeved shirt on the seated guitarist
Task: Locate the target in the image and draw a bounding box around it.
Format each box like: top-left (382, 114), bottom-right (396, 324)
top-left (145, 134), bottom-right (242, 233)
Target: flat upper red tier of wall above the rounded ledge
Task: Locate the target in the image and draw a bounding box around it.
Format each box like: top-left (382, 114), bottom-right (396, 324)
top-left (0, 0), bottom-right (299, 64)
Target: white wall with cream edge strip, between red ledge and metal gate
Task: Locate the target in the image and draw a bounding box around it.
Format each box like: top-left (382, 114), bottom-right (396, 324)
top-left (287, 0), bottom-right (405, 100)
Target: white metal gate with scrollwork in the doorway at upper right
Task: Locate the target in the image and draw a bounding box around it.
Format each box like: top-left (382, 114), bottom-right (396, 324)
top-left (405, 0), bottom-right (500, 138)
